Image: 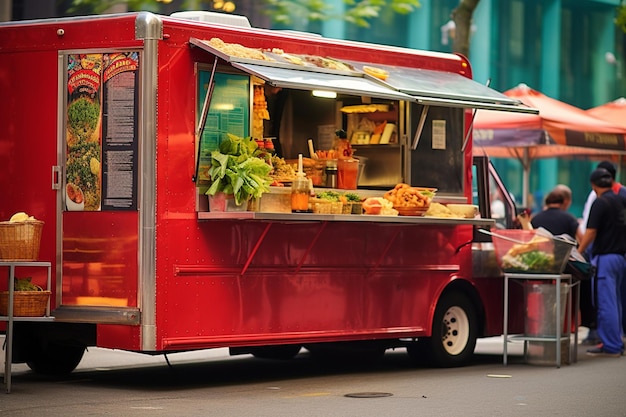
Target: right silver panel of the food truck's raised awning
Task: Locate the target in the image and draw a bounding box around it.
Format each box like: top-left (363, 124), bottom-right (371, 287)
top-left (346, 61), bottom-right (539, 114)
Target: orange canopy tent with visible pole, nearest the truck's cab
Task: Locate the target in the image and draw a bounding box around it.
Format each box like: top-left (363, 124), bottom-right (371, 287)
top-left (473, 84), bottom-right (626, 205)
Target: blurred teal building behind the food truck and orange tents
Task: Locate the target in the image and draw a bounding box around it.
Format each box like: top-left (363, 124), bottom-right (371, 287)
top-left (0, 0), bottom-right (626, 217)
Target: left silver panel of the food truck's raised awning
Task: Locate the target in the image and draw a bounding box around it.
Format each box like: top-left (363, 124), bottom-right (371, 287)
top-left (231, 62), bottom-right (412, 101)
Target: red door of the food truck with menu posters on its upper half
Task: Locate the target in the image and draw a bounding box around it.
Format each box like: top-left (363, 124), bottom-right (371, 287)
top-left (54, 51), bottom-right (139, 323)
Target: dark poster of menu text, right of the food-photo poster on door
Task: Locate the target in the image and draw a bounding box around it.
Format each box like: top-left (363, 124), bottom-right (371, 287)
top-left (102, 52), bottom-right (139, 210)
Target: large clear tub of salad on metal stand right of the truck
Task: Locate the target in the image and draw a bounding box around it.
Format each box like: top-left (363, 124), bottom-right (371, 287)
top-left (490, 229), bottom-right (575, 274)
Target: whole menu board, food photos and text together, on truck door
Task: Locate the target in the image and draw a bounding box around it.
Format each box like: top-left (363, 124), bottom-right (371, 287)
top-left (64, 52), bottom-right (139, 211)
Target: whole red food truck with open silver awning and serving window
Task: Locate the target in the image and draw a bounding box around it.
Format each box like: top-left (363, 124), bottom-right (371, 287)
top-left (0, 12), bottom-right (534, 374)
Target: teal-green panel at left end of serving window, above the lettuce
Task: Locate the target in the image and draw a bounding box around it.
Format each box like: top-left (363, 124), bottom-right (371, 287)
top-left (196, 70), bottom-right (251, 183)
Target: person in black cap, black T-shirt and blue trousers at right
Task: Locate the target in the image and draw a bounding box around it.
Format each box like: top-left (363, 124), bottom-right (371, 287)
top-left (578, 168), bottom-right (626, 357)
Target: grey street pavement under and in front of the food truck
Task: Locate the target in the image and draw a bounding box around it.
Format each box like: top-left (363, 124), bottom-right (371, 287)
top-left (0, 331), bottom-right (626, 417)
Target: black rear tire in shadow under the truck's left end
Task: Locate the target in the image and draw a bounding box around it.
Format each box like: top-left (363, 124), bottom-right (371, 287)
top-left (26, 342), bottom-right (85, 375)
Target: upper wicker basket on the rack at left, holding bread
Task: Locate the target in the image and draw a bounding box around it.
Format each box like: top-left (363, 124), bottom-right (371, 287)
top-left (0, 220), bottom-right (44, 261)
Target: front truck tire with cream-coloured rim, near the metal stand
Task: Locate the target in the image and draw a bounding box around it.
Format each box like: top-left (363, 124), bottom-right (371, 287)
top-left (407, 292), bottom-right (477, 368)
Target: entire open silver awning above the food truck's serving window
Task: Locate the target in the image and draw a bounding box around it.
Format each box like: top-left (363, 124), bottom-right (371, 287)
top-left (189, 37), bottom-right (539, 114)
